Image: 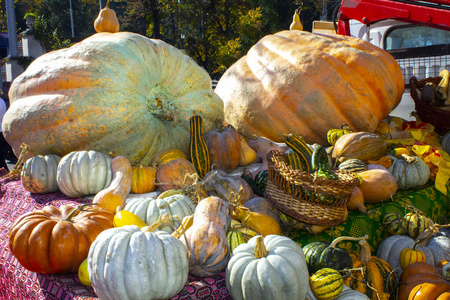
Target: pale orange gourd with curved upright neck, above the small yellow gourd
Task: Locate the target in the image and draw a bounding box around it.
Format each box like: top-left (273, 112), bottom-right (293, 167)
top-left (92, 156), bottom-right (133, 213)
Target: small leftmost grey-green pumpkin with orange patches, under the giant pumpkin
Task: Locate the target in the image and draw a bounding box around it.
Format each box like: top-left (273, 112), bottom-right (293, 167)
top-left (20, 154), bottom-right (61, 194)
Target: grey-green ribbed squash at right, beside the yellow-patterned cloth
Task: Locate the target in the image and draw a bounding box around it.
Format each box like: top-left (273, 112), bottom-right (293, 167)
top-left (387, 154), bottom-right (430, 189)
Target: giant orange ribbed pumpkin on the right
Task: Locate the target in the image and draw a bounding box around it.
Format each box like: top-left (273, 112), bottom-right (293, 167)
top-left (215, 30), bottom-right (404, 145)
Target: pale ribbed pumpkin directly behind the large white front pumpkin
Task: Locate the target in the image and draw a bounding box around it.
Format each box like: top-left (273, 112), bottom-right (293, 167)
top-left (124, 194), bottom-right (195, 233)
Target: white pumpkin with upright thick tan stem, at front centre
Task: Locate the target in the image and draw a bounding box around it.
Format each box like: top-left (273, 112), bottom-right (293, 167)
top-left (225, 235), bottom-right (309, 300)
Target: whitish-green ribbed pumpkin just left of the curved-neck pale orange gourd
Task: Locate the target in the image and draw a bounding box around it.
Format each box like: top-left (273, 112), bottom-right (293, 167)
top-left (56, 150), bottom-right (113, 197)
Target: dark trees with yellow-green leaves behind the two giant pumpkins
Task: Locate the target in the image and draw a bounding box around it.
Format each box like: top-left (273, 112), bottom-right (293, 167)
top-left (0, 0), bottom-right (339, 79)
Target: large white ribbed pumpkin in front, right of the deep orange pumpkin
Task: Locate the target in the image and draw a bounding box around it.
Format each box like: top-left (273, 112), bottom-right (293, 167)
top-left (88, 225), bottom-right (189, 300)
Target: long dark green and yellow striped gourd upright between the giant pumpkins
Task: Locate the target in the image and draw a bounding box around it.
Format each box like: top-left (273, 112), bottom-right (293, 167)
top-left (189, 115), bottom-right (211, 178)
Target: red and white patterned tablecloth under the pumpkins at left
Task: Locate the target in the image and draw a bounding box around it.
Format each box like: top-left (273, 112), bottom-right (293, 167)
top-left (0, 169), bottom-right (231, 300)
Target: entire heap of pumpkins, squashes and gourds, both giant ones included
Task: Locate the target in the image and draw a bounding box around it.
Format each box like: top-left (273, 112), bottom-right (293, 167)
top-left (3, 1), bottom-right (450, 300)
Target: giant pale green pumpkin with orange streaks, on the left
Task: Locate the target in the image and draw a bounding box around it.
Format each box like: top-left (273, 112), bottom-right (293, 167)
top-left (2, 32), bottom-right (224, 165)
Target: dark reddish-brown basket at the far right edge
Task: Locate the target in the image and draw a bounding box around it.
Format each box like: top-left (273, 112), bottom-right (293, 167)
top-left (409, 76), bottom-right (450, 135)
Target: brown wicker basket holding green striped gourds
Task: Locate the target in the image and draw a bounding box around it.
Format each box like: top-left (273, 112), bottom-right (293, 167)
top-left (265, 150), bottom-right (359, 225)
